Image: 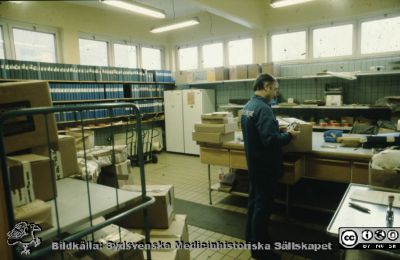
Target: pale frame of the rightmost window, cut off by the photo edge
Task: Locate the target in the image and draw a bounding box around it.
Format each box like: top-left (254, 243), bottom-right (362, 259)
top-left (357, 11), bottom-right (400, 58)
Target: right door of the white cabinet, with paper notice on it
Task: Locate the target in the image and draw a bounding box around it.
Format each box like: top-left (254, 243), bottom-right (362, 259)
top-left (183, 89), bottom-right (203, 154)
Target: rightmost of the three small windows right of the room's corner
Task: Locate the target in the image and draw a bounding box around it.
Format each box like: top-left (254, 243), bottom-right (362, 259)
top-left (228, 39), bottom-right (253, 65)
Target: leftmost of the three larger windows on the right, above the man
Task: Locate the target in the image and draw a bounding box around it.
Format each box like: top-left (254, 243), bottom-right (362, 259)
top-left (271, 31), bottom-right (306, 61)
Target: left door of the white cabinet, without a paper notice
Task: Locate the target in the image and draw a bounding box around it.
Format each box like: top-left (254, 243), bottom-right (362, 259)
top-left (164, 90), bottom-right (185, 153)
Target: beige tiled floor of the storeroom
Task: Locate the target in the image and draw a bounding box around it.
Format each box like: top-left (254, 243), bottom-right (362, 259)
top-left (133, 152), bottom-right (305, 260)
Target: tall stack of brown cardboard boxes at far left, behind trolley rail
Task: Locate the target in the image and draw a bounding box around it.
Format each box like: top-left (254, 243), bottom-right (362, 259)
top-left (0, 81), bottom-right (78, 258)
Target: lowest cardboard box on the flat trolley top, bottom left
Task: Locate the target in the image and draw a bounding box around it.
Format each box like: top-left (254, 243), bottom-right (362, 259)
top-left (14, 200), bottom-right (53, 230)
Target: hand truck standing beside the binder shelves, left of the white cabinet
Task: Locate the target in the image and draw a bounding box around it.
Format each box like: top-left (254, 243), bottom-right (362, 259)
top-left (126, 111), bottom-right (162, 166)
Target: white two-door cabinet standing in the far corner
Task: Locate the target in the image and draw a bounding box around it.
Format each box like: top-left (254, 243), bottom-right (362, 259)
top-left (164, 89), bottom-right (215, 154)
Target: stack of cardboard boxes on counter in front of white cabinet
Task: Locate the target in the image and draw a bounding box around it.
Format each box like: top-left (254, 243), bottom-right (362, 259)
top-left (192, 112), bottom-right (237, 144)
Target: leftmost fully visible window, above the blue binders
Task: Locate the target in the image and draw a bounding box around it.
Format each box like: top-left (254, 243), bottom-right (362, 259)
top-left (12, 28), bottom-right (57, 62)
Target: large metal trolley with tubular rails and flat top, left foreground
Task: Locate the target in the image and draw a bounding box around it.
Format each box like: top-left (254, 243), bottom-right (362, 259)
top-left (0, 103), bottom-right (155, 259)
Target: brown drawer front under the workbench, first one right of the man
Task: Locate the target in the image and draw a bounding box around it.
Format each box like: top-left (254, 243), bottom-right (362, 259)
top-left (305, 157), bottom-right (351, 182)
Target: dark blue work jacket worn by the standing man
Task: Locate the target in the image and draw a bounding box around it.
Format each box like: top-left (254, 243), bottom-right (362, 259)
top-left (241, 95), bottom-right (291, 179)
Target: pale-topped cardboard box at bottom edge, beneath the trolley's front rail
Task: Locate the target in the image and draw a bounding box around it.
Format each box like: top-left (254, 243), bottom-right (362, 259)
top-left (86, 225), bottom-right (144, 260)
